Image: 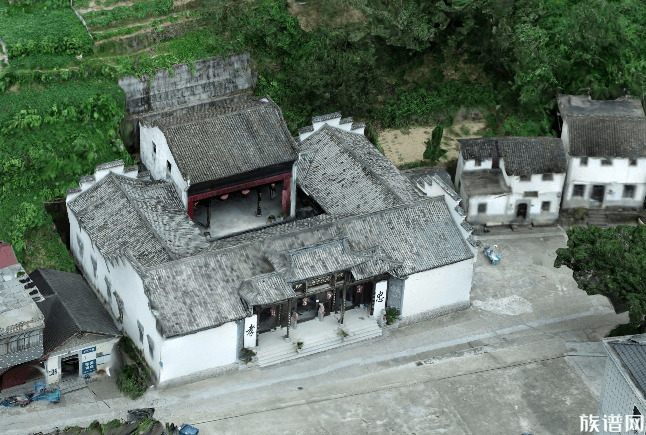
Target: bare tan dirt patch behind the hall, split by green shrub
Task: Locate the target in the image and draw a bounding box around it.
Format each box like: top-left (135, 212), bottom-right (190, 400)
top-left (379, 116), bottom-right (487, 166)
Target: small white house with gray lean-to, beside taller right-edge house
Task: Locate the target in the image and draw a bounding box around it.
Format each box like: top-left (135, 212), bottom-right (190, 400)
top-left (455, 137), bottom-right (567, 225)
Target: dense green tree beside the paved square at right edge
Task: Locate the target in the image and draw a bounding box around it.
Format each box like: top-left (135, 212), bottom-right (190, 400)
top-left (554, 225), bottom-right (646, 328)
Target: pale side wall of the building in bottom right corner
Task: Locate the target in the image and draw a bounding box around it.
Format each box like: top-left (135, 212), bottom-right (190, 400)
top-left (597, 357), bottom-right (646, 435)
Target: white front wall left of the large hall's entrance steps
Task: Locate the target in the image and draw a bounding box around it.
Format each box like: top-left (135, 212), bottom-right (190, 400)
top-left (158, 322), bottom-right (238, 382)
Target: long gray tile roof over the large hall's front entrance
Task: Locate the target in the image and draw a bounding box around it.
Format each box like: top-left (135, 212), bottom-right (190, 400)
top-left (145, 197), bottom-right (473, 337)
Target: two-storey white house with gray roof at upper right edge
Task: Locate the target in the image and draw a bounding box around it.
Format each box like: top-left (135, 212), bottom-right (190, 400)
top-left (558, 95), bottom-right (646, 209)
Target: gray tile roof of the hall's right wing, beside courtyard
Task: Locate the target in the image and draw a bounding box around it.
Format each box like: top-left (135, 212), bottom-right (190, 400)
top-left (296, 125), bottom-right (421, 215)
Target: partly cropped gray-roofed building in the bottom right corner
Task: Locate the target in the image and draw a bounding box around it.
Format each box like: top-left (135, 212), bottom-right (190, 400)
top-left (598, 334), bottom-right (646, 435)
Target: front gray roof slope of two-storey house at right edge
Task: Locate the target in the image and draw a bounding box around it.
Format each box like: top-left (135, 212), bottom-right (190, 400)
top-left (567, 115), bottom-right (646, 159)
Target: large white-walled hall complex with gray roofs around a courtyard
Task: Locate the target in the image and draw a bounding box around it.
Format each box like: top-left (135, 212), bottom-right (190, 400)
top-left (67, 104), bottom-right (477, 382)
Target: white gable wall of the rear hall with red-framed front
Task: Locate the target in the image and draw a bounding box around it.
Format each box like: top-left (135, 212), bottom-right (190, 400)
top-left (139, 124), bottom-right (190, 207)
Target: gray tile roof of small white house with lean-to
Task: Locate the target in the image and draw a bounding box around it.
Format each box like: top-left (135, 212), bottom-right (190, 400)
top-left (458, 136), bottom-right (567, 176)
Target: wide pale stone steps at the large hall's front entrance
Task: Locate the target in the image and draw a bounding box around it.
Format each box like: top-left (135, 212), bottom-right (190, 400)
top-left (257, 319), bottom-right (382, 367)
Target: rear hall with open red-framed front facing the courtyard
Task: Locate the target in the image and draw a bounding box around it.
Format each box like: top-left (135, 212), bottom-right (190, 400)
top-left (139, 96), bottom-right (298, 236)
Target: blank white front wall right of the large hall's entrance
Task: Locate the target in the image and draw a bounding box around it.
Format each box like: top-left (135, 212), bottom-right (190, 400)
top-left (402, 259), bottom-right (473, 316)
